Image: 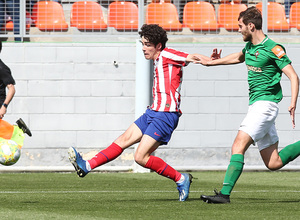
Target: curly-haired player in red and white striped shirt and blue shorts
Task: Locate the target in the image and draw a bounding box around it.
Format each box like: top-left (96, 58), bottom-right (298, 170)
top-left (69, 24), bottom-right (210, 201)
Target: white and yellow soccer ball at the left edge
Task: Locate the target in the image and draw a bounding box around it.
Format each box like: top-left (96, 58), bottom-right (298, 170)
top-left (0, 138), bottom-right (21, 166)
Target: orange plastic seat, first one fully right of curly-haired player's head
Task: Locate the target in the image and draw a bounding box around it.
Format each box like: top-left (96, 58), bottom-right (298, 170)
top-left (183, 2), bottom-right (219, 31)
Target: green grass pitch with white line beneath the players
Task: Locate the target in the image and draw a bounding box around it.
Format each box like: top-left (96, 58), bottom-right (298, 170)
top-left (0, 172), bottom-right (300, 220)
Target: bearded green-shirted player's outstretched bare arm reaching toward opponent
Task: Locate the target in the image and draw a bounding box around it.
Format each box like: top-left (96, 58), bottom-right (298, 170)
top-left (201, 51), bottom-right (245, 66)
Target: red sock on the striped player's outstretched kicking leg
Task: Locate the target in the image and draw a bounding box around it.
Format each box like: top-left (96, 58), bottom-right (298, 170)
top-left (88, 143), bottom-right (123, 169)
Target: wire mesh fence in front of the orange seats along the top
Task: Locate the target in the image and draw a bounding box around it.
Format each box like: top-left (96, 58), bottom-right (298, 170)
top-left (0, 0), bottom-right (300, 42)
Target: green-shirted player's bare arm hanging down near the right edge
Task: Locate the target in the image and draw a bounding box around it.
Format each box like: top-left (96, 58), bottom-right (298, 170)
top-left (282, 64), bottom-right (299, 128)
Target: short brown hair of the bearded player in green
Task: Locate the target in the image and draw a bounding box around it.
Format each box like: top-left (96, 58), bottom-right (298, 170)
top-left (238, 6), bottom-right (262, 30)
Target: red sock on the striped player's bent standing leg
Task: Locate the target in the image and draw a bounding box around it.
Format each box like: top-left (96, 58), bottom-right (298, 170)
top-left (145, 155), bottom-right (181, 182)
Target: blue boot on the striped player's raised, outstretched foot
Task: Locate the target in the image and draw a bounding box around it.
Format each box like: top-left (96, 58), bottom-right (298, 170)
top-left (68, 147), bottom-right (90, 177)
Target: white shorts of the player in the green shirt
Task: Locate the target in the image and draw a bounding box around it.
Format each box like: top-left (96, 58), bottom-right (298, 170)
top-left (239, 101), bottom-right (279, 151)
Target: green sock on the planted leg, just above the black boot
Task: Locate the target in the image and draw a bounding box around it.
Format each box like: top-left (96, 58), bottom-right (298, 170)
top-left (221, 154), bottom-right (244, 195)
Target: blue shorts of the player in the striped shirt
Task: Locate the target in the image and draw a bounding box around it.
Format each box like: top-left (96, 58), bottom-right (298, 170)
top-left (134, 109), bottom-right (180, 145)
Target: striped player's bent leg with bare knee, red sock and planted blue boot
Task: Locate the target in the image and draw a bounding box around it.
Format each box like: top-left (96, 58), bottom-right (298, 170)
top-left (134, 135), bottom-right (192, 201)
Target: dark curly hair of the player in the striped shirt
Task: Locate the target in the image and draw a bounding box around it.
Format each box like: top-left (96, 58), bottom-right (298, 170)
top-left (139, 24), bottom-right (168, 49)
